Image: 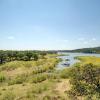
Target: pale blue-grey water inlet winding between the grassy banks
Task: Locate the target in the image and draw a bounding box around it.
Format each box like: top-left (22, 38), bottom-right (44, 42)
top-left (57, 52), bottom-right (100, 69)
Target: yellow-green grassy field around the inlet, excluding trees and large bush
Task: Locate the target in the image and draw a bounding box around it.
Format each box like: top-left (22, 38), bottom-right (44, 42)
top-left (0, 54), bottom-right (100, 100)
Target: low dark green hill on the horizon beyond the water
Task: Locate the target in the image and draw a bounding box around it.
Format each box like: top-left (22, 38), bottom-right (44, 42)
top-left (59, 47), bottom-right (100, 53)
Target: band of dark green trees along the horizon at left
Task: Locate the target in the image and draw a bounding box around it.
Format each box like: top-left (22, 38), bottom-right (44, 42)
top-left (0, 50), bottom-right (56, 64)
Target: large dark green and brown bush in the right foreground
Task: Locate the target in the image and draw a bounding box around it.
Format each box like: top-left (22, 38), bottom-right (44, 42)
top-left (69, 63), bottom-right (100, 97)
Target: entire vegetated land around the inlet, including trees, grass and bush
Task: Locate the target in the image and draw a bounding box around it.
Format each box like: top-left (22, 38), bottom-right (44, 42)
top-left (0, 51), bottom-right (100, 100)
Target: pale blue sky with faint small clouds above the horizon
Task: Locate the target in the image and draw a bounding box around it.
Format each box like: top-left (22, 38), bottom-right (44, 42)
top-left (0, 0), bottom-right (100, 50)
